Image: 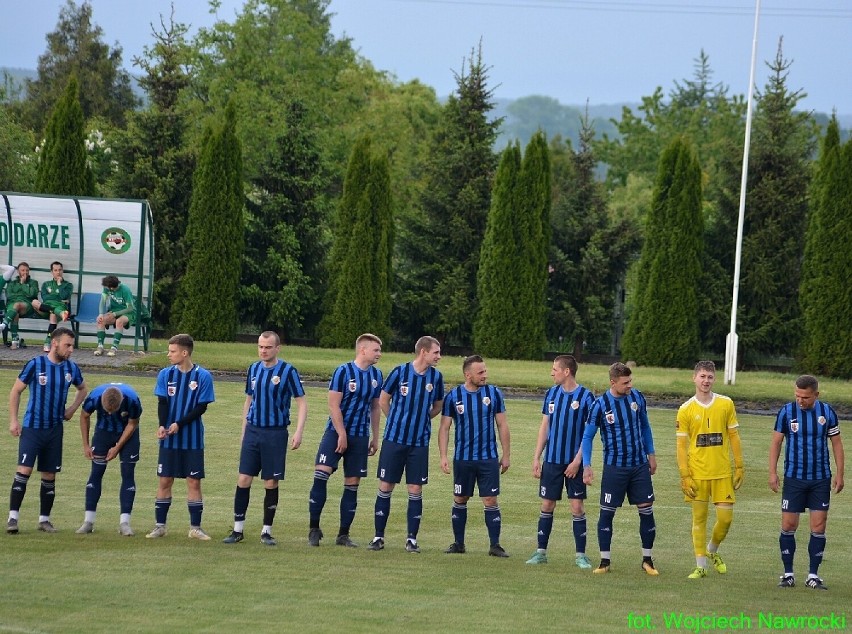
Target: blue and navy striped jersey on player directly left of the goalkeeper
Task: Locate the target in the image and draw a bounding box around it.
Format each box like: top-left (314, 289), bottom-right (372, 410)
top-left (583, 389), bottom-right (654, 467)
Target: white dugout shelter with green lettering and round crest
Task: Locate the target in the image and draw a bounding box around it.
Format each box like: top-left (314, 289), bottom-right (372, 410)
top-left (0, 192), bottom-right (154, 350)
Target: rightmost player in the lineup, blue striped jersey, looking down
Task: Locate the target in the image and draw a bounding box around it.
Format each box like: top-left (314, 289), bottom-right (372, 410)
top-left (769, 374), bottom-right (844, 590)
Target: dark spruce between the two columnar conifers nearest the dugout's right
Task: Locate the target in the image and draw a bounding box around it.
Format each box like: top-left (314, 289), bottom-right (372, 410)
top-left (240, 101), bottom-right (330, 337)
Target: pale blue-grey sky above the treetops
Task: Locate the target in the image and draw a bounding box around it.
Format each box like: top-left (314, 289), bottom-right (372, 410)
top-left (0, 0), bottom-right (852, 114)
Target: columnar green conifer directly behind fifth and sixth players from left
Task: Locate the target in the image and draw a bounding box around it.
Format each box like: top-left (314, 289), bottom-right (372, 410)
top-left (320, 137), bottom-right (393, 347)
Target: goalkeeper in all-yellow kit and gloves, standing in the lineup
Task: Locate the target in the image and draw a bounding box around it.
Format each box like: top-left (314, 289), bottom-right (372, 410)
top-left (676, 361), bottom-right (745, 579)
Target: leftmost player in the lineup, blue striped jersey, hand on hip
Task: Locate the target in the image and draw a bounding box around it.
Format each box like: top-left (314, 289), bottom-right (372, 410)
top-left (6, 328), bottom-right (87, 535)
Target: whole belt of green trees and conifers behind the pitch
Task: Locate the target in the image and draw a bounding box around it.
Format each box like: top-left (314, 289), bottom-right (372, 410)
top-left (0, 0), bottom-right (852, 378)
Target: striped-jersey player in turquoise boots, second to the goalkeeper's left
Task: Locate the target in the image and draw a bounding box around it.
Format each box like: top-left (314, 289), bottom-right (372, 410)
top-left (527, 354), bottom-right (595, 570)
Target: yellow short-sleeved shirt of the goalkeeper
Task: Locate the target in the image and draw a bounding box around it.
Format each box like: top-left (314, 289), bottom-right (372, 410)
top-left (676, 394), bottom-right (739, 480)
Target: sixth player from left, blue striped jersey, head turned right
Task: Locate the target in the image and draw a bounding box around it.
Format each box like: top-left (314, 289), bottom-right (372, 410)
top-left (367, 336), bottom-right (444, 553)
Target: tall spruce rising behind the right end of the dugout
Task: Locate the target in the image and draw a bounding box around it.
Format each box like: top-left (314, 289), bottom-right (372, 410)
top-left (111, 17), bottom-right (195, 331)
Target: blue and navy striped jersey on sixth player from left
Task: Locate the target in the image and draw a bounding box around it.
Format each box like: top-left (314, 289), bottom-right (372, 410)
top-left (382, 362), bottom-right (444, 447)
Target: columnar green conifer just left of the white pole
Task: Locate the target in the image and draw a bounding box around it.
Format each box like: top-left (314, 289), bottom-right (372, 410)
top-left (624, 137), bottom-right (704, 367)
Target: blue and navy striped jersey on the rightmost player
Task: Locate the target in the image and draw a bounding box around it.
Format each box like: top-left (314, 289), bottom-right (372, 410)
top-left (775, 401), bottom-right (840, 480)
